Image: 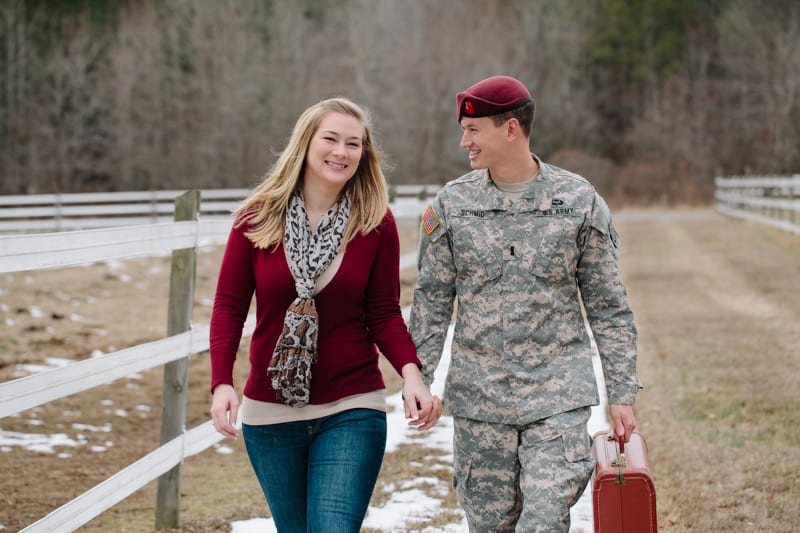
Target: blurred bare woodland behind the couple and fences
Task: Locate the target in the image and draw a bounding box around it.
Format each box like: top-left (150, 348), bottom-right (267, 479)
top-left (0, 0), bottom-right (800, 205)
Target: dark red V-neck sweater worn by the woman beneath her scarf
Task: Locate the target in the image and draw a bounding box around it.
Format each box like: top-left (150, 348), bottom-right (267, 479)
top-left (210, 211), bottom-right (421, 404)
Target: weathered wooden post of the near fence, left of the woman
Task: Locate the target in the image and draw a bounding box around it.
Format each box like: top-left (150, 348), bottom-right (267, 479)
top-left (156, 190), bottom-right (200, 529)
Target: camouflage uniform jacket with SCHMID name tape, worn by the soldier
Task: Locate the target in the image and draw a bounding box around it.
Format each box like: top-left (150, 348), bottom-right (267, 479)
top-left (410, 158), bottom-right (641, 425)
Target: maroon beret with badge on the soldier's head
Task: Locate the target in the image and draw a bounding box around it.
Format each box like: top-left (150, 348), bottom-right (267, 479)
top-left (456, 76), bottom-right (531, 122)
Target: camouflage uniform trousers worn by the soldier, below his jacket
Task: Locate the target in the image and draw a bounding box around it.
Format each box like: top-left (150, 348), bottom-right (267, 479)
top-left (453, 407), bottom-right (594, 533)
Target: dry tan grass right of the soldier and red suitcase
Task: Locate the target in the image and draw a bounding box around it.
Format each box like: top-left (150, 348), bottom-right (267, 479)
top-left (619, 210), bottom-right (800, 532)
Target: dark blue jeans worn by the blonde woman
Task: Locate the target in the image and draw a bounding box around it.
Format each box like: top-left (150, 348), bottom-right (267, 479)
top-left (242, 409), bottom-right (386, 533)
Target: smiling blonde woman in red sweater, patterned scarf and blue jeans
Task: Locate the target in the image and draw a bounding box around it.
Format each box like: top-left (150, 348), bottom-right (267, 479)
top-left (211, 98), bottom-right (442, 533)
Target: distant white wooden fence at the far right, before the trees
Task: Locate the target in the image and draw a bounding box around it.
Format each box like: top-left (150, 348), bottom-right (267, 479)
top-left (714, 174), bottom-right (800, 234)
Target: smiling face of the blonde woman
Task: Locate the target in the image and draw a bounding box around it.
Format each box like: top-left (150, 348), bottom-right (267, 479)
top-left (304, 112), bottom-right (364, 192)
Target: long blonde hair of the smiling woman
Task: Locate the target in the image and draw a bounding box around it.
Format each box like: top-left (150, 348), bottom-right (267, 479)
top-left (233, 97), bottom-right (389, 249)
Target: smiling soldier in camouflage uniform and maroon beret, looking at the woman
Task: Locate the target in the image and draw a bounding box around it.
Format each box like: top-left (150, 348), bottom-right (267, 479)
top-left (411, 76), bottom-right (641, 533)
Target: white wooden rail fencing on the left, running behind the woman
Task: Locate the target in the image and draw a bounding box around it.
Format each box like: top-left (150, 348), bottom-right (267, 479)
top-left (0, 186), bottom-right (438, 533)
